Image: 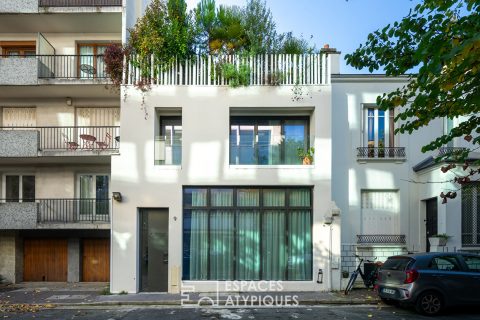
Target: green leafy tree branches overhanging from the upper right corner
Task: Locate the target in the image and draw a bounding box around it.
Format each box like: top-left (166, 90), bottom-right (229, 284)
top-left (345, 0), bottom-right (480, 160)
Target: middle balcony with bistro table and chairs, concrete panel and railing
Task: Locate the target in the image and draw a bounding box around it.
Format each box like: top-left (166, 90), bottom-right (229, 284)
top-left (0, 126), bottom-right (120, 158)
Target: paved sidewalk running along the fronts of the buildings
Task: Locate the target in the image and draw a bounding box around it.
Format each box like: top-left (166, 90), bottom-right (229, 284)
top-left (0, 282), bottom-right (379, 307)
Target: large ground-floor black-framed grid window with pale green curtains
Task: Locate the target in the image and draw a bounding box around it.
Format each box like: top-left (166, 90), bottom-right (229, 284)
top-left (183, 187), bottom-right (312, 280)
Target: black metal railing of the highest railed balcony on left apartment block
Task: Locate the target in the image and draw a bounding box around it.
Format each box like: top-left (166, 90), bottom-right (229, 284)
top-left (37, 55), bottom-right (107, 79)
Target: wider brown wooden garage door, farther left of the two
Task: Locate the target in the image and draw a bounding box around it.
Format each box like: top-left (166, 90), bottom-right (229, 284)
top-left (23, 239), bottom-right (68, 281)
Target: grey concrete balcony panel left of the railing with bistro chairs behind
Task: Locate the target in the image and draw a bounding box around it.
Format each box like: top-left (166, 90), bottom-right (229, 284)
top-left (0, 130), bottom-right (40, 158)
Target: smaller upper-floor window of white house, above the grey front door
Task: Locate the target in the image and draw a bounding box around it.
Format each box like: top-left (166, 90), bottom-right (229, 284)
top-left (155, 116), bottom-right (182, 165)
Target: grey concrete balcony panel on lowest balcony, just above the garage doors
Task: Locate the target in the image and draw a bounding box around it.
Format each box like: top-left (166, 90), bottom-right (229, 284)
top-left (0, 202), bottom-right (38, 230)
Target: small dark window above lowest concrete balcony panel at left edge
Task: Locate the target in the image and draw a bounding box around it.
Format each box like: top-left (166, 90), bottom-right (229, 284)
top-left (5, 175), bottom-right (35, 202)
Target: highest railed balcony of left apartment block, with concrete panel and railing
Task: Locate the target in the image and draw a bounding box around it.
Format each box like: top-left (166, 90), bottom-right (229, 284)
top-left (0, 55), bottom-right (108, 85)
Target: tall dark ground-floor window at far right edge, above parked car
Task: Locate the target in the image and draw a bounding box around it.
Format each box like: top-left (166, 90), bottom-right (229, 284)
top-left (462, 183), bottom-right (480, 247)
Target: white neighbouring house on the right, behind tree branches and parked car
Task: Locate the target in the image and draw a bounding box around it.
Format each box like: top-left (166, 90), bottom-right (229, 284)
top-left (332, 74), bottom-right (480, 278)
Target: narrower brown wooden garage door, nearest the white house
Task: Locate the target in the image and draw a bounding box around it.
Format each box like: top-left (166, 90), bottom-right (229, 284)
top-left (82, 239), bottom-right (110, 282)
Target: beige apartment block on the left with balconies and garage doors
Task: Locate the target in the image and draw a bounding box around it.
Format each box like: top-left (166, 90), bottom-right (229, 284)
top-left (0, 0), bottom-right (122, 282)
